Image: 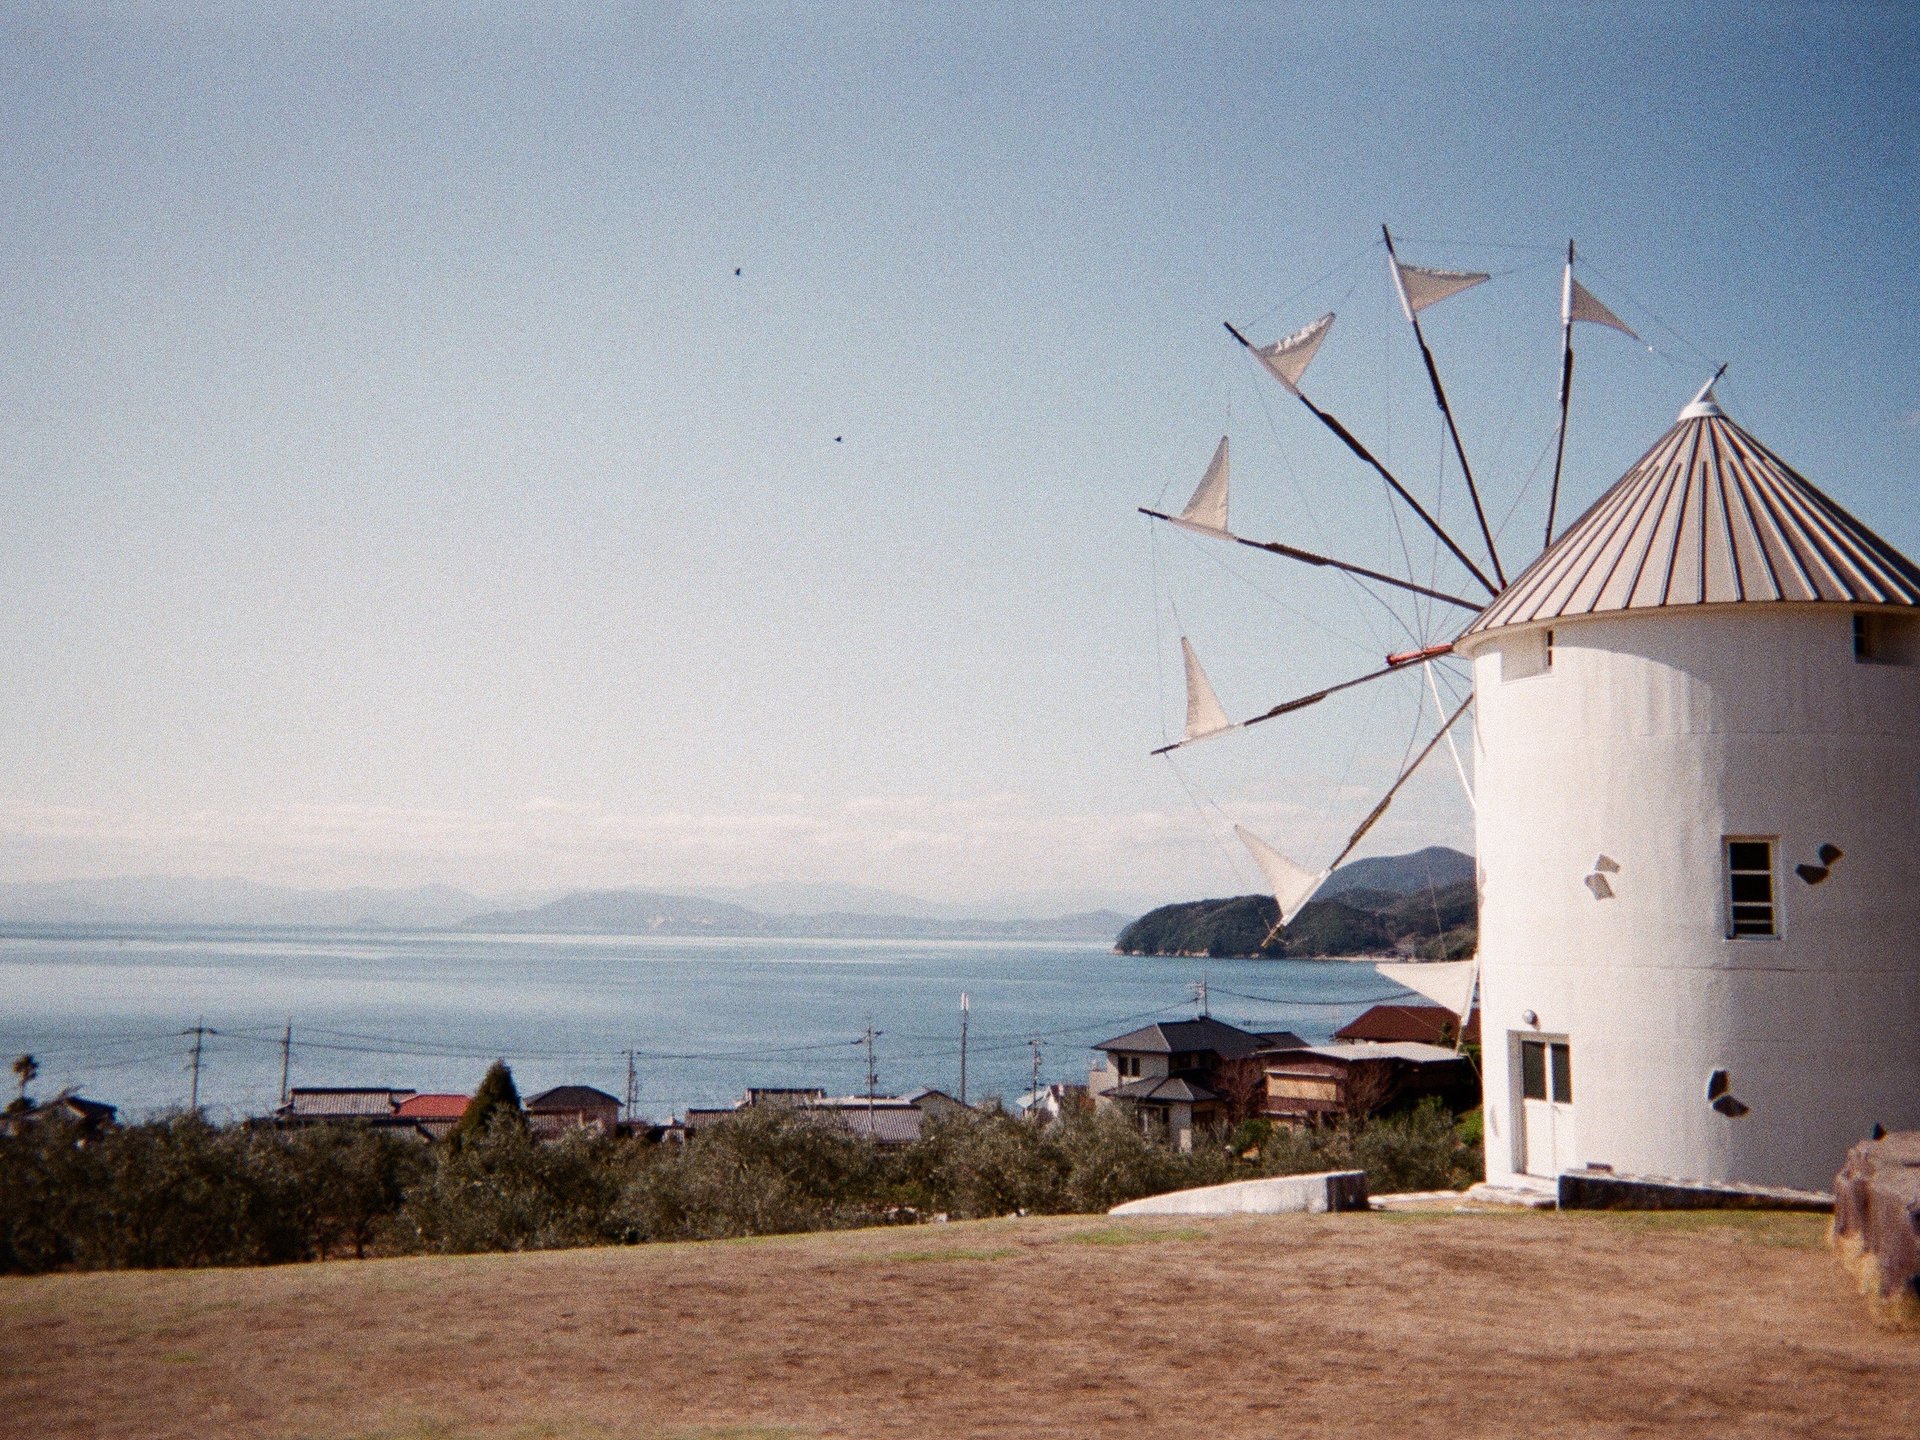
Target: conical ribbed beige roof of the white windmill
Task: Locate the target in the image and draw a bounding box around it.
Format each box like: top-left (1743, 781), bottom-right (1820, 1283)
top-left (1463, 386), bottom-right (1920, 637)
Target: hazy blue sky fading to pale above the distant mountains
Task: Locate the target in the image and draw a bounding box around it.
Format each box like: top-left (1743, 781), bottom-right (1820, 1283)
top-left (0, 4), bottom-right (1920, 900)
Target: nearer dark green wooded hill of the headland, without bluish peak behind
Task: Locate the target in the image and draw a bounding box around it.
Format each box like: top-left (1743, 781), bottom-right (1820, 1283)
top-left (1114, 879), bottom-right (1478, 960)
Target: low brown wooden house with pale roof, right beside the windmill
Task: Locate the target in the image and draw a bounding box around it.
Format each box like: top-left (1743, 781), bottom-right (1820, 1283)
top-left (1260, 1041), bottom-right (1480, 1125)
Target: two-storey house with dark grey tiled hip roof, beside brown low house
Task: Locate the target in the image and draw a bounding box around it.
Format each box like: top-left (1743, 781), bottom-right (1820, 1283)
top-left (1087, 1016), bottom-right (1306, 1150)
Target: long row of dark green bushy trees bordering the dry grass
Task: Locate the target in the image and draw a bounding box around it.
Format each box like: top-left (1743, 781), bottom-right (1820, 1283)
top-left (0, 1068), bottom-right (1480, 1273)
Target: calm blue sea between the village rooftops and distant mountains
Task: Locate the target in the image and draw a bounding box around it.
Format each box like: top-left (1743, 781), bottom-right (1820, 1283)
top-left (0, 927), bottom-right (1405, 1117)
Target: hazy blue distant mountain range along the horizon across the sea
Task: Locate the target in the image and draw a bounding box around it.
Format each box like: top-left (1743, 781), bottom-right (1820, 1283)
top-left (0, 877), bottom-right (1127, 941)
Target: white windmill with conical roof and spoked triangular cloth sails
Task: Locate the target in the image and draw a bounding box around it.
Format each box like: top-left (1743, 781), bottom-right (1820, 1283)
top-left (1148, 236), bottom-right (1920, 1188)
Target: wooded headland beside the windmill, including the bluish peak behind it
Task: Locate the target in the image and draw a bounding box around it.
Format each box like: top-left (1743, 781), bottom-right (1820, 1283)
top-left (1114, 847), bottom-right (1478, 960)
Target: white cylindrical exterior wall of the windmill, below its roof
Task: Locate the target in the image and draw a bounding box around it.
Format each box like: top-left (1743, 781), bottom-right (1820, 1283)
top-left (1461, 605), bottom-right (1920, 1190)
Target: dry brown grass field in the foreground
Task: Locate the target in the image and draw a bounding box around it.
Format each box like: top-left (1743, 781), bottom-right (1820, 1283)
top-left (0, 1213), bottom-right (1920, 1440)
